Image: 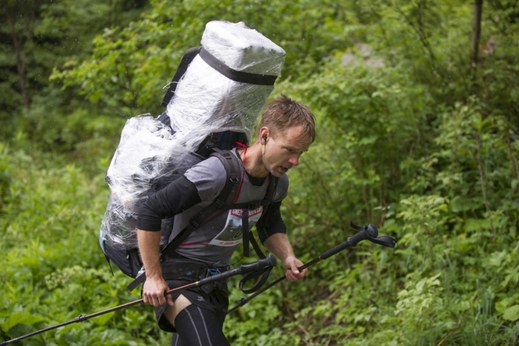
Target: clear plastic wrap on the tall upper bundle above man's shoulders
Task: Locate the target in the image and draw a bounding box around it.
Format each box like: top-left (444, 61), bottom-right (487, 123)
top-left (167, 21), bottom-right (285, 148)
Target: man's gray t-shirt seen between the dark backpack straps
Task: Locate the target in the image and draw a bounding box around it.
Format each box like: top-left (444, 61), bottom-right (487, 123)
top-left (170, 150), bottom-right (288, 265)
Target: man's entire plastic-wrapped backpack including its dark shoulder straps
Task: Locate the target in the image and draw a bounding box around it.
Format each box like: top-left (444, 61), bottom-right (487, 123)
top-left (100, 21), bottom-right (284, 289)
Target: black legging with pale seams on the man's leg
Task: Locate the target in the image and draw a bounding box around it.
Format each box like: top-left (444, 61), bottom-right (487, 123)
top-left (171, 304), bottom-right (230, 346)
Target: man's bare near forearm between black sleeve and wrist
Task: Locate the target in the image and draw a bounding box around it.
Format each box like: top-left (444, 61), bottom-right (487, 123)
top-left (137, 230), bottom-right (162, 278)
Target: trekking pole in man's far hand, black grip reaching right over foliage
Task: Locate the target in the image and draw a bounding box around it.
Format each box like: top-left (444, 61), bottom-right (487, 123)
top-left (227, 223), bottom-right (396, 314)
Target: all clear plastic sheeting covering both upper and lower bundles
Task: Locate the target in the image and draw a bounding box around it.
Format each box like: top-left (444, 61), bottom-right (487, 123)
top-left (100, 21), bottom-right (285, 249)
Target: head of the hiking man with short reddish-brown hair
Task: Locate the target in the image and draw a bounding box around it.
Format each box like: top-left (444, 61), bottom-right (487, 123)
top-left (256, 95), bottom-right (315, 177)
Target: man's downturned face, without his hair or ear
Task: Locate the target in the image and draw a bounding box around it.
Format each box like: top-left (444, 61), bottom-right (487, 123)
top-left (263, 125), bottom-right (311, 177)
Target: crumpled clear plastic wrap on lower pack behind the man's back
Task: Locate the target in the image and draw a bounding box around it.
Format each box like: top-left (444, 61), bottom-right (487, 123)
top-left (101, 114), bottom-right (184, 249)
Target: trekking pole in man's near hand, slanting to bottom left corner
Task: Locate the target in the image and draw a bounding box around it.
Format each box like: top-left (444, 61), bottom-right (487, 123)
top-left (0, 254), bottom-right (276, 346)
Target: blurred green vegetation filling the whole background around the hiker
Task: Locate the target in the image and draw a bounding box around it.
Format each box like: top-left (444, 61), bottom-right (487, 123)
top-left (0, 0), bottom-right (519, 345)
